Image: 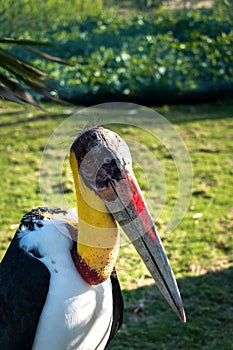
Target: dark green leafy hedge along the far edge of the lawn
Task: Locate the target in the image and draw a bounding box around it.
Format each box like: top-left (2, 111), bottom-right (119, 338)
top-left (5, 9), bottom-right (233, 104)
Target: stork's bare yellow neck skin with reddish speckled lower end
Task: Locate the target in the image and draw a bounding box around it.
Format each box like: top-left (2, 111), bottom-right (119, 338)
top-left (70, 151), bottom-right (119, 284)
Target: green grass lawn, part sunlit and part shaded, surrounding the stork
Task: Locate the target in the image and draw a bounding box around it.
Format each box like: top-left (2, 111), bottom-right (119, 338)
top-left (0, 102), bottom-right (233, 350)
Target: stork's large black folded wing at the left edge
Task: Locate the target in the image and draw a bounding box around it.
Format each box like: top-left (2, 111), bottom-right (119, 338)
top-left (0, 233), bottom-right (50, 350)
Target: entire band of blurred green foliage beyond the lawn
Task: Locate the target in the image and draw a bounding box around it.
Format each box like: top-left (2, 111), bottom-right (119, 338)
top-left (0, 0), bottom-right (233, 105)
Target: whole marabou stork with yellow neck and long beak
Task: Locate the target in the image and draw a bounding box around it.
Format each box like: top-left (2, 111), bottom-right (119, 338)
top-left (0, 126), bottom-right (185, 350)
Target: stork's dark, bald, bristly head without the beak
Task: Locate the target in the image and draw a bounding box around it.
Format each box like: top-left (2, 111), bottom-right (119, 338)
top-left (71, 126), bottom-right (127, 190)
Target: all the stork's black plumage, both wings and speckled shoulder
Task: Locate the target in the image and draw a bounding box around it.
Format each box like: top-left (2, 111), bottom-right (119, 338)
top-left (0, 208), bottom-right (123, 350)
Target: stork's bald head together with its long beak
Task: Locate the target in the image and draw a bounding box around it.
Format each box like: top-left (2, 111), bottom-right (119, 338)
top-left (71, 127), bottom-right (185, 322)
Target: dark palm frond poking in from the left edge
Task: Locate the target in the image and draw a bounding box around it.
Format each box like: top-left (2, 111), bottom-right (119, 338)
top-left (0, 38), bottom-right (69, 107)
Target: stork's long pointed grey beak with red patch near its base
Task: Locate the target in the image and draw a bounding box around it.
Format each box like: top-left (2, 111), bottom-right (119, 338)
top-left (99, 171), bottom-right (186, 322)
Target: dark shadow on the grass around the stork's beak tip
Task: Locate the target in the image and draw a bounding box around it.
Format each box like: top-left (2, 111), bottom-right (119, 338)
top-left (110, 268), bottom-right (233, 350)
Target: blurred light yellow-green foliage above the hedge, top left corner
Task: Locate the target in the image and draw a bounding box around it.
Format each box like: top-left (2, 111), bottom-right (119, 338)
top-left (0, 0), bottom-right (103, 34)
